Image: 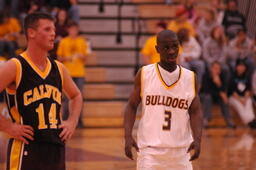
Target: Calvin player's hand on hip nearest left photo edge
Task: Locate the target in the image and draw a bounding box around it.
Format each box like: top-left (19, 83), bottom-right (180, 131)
top-left (6, 123), bottom-right (34, 144)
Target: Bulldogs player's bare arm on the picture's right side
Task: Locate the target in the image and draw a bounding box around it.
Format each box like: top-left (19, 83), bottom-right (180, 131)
top-left (188, 75), bottom-right (203, 161)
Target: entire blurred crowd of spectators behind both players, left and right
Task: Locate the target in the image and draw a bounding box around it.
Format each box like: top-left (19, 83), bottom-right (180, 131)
top-left (0, 0), bottom-right (256, 128)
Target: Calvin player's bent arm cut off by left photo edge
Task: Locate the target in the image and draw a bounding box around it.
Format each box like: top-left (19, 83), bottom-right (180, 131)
top-left (0, 60), bottom-right (34, 144)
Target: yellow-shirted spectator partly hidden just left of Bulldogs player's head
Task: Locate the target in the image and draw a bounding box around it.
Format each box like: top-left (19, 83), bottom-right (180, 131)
top-left (140, 21), bottom-right (166, 64)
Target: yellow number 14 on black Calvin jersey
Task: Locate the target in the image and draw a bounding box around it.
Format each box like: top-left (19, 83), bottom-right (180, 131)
top-left (36, 103), bottom-right (58, 129)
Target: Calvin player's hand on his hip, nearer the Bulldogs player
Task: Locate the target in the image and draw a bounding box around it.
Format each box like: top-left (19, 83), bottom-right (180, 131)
top-left (59, 120), bottom-right (77, 142)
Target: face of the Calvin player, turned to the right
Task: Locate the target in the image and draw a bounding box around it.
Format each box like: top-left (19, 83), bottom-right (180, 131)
top-left (33, 19), bottom-right (55, 50)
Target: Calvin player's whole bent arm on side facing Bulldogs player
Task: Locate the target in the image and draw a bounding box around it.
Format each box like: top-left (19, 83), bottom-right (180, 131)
top-left (59, 65), bottom-right (83, 141)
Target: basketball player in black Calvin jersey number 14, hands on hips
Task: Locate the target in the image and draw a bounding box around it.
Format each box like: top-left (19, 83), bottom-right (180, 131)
top-left (0, 13), bottom-right (82, 170)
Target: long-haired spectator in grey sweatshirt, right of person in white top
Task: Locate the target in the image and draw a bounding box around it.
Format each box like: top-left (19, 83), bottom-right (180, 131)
top-left (203, 26), bottom-right (229, 83)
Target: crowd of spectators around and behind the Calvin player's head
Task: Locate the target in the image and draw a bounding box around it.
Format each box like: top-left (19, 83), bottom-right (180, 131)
top-left (0, 0), bottom-right (80, 59)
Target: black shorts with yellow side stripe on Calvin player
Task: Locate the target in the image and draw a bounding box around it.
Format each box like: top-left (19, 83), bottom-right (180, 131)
top-left (7, 139), bottom-right (65, 170)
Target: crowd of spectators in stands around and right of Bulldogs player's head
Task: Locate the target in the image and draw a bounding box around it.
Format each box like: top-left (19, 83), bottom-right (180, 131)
top-left (141, 0), bottom-right (256, 128)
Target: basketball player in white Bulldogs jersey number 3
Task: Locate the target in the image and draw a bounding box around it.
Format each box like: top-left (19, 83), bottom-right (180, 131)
top-left (124, 30), bottom-right (202, 170)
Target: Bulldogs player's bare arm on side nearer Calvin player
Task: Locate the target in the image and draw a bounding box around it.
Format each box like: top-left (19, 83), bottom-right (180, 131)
top-left (124, 70), bottom-right (141, 160)
